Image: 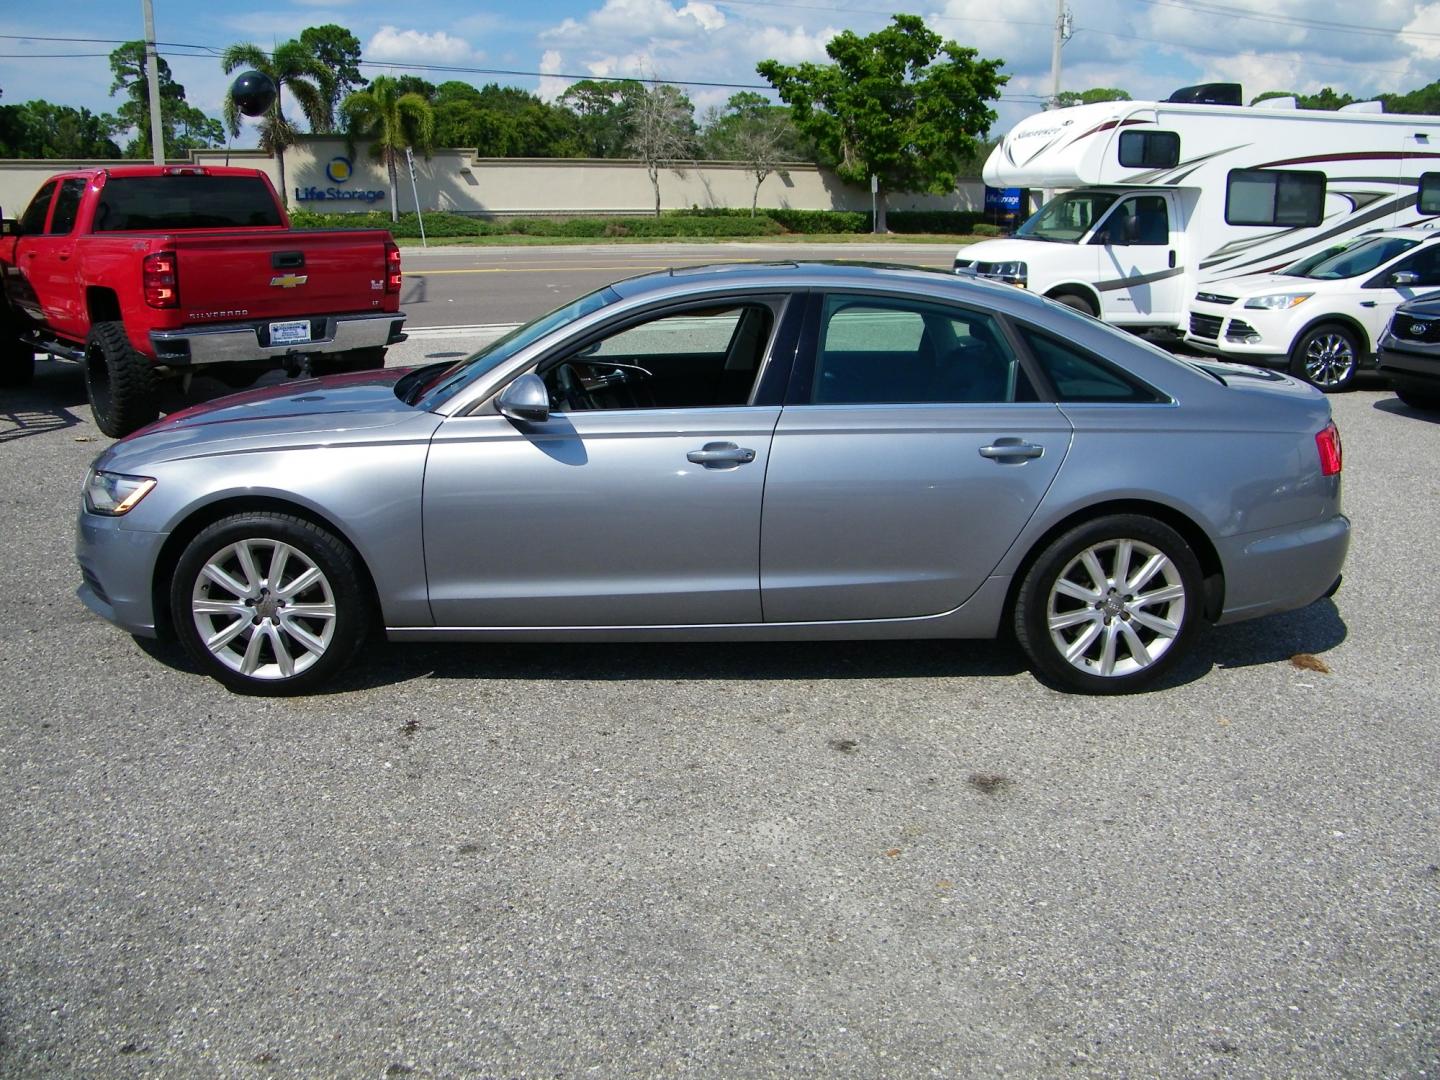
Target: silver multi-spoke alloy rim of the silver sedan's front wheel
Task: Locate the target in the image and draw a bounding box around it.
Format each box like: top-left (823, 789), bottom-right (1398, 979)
top-left (190, 537), bottom-right (336, 680)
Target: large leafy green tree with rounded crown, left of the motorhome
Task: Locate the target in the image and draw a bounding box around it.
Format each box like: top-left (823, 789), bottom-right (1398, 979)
top-left (756, 14), bottom-right (1008, 230)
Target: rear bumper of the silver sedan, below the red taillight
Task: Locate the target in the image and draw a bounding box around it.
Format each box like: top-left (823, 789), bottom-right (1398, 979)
top-left (1215, 514), bottom-right (1349, 622)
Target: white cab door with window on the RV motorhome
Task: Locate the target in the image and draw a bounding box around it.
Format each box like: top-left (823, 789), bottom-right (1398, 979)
top-left (1090, 190), bottom-right (1185, 325)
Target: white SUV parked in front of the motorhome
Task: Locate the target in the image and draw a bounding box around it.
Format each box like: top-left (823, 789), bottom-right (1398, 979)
top-left (1185, 229), bottom-right (1440, 392)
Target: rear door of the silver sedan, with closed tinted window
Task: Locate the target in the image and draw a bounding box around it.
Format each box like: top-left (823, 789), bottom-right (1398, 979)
top-left (760, 292), bottom-right (1070, 622)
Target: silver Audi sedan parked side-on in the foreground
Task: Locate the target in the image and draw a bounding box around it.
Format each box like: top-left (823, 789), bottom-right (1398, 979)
top-left (76, 264), bottom-right (1349, 694)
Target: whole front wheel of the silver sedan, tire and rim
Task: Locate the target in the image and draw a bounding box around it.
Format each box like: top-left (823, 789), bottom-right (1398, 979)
top-left (170, 513), bottom-right (376, 696)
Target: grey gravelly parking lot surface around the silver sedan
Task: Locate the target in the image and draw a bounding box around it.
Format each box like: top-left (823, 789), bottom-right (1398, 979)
top-left (0, 333), bottom-right (1440, 1077)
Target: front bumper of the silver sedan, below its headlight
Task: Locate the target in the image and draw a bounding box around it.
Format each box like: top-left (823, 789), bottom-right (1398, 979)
top-left (75, 510), bottom-right (167, 638)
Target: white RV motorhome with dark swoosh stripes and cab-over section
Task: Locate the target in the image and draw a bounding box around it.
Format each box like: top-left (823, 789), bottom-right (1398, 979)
top-left (955, 84), bottom-right (1440, 328)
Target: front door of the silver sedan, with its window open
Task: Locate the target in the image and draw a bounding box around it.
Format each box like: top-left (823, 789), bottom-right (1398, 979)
top-left (423, 297), bottom-right (799, 626)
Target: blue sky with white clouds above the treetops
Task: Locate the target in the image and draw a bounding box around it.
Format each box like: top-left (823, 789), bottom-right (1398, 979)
top-left (0, 0), bottom-right (1440, 145)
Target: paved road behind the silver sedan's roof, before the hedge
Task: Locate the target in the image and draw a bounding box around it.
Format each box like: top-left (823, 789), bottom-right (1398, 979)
top-left (400, 243), bottom-right (956, 328)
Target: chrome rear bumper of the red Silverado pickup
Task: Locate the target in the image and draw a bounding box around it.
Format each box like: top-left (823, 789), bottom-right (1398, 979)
top-left (150, 311), bottom-right (405, 367)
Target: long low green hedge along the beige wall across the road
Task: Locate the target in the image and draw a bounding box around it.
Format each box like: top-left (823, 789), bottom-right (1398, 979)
top-left (289, 207), bottom-right (994, 239)
